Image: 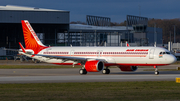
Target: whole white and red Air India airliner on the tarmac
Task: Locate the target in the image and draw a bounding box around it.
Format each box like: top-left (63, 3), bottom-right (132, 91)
top-left (19, 20), bottom-right (177, 75)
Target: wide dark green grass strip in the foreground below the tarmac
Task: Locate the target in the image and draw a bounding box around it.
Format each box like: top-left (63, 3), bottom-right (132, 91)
top-left (0, 81), bottom-right (180, 101)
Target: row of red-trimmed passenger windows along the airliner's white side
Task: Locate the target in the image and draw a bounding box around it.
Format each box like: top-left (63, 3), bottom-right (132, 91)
top-left (44, 52), bottom-right (148, 54)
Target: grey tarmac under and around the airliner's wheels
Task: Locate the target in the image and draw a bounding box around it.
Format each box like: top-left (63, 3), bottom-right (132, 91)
top-left (0, 61), bottom-right (180, 83)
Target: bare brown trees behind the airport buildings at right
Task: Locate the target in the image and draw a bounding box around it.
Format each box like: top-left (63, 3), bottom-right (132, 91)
top-left (111, 19), bottom-right (180, 44)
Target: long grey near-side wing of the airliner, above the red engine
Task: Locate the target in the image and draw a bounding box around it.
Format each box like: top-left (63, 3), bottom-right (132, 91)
top-left (34, 54), bottom-right (106, 62)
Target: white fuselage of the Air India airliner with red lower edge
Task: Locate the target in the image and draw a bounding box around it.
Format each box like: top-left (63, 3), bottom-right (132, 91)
top-left (21, 47), bottom-right (176, 66)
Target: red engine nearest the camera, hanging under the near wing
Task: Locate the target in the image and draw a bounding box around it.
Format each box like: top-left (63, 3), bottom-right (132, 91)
top-left (85, 60), bottom-right (104, 72)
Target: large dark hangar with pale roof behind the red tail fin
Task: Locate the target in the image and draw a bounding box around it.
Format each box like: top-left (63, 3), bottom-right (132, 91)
top-left (0, 5), bottom-right (69, 49)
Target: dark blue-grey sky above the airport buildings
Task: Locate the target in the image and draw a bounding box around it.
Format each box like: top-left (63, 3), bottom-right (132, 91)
top-left (0, 0), bottom-right (180, 23)
